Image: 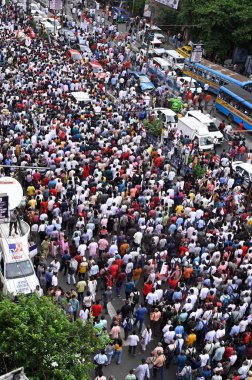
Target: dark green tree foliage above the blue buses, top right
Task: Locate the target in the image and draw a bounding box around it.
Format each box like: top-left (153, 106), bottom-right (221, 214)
top-left (178, 0), bottom-right (252, 59)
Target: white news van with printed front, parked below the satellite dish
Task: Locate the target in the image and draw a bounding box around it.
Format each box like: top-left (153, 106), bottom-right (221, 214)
top-left (0, 221), bottom-right (39, 296)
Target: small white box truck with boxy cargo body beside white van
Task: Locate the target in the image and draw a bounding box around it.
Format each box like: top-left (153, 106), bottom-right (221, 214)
top-left (178, 116), bottom-right (214, 152)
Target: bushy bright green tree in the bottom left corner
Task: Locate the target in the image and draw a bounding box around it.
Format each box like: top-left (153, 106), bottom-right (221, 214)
top-left (0, 295), bottom-right (108, 380)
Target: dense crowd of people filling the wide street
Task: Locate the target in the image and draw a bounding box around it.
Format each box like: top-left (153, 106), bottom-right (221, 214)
top-left (0, 2), bottom-right (252, 380)
